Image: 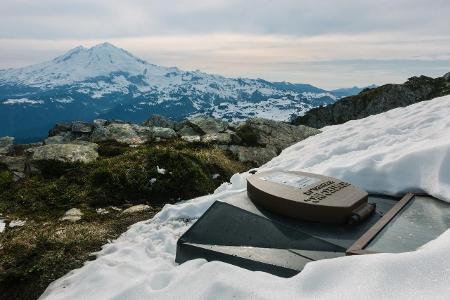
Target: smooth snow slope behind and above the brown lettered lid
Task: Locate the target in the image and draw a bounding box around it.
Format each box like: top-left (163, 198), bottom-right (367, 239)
top-left (263, 96), bottom-right (450, 202)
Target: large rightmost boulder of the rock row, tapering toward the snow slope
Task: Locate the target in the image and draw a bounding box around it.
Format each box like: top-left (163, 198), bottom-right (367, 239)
top-left (236, 118), bottom-right (320, 152)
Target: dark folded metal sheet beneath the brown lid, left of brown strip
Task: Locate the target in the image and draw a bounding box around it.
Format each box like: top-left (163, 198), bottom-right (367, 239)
top-left (176, 192), bottom-right (396, 277)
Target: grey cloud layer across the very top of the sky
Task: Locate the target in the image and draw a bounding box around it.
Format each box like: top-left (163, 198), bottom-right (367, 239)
top-left (0, 0), bottom-right (450, 39)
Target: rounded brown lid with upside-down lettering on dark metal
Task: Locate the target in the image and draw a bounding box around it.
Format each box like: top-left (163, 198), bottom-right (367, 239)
top-left (247, 171), bottom-right (375, 224)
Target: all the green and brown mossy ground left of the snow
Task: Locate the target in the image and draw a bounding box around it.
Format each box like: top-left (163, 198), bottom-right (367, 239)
top-left (0, 141), bottom-right (249, 299)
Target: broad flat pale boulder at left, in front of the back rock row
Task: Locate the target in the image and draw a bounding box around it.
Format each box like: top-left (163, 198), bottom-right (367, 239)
top-left (27, 144), bottom-right (98, 163)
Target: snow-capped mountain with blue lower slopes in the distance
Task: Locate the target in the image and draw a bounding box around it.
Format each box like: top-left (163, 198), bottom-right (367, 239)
top-left (0, 43), bottom-right (338, 138)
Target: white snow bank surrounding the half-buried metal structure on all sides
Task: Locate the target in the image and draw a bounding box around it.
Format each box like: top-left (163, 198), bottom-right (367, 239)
top-left (41, 96), bottom-right (450, 299)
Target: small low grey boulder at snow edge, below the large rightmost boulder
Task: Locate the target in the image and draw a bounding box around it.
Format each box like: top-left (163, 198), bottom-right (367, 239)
top-left (227, 145), bottom-right (278, 166)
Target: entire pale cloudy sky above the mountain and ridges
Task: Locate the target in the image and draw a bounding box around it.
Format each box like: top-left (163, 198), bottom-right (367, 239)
top-left (0, 0), bottom-right (450, 89)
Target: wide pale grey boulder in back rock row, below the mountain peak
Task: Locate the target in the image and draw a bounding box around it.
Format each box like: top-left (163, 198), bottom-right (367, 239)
top-left (91, 123), bottom-right (153, 145)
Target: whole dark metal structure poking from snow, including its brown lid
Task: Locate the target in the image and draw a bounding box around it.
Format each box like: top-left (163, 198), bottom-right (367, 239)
top-left (175, 171), bottom-right (450, 277)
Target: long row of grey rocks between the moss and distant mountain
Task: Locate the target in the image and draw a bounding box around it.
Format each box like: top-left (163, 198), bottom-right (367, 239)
top-left (0, 116), bottom-right (320, 178)
